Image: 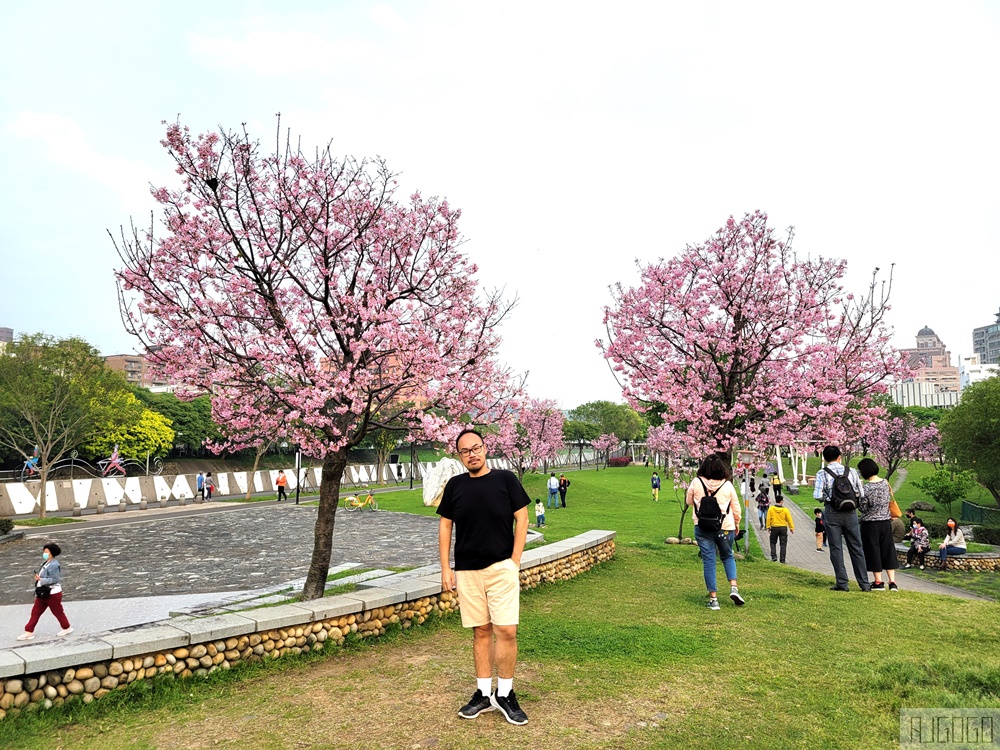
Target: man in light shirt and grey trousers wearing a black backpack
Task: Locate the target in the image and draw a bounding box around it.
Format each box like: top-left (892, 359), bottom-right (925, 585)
top-left (813, 445), bottom-right (871, 591)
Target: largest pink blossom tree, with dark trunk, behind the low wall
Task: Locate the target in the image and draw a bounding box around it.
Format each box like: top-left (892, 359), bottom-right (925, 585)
top-left (113, 124), bottom-right (513, 598)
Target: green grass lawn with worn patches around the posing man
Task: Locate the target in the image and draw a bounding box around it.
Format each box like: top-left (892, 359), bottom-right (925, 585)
top-left (0, 467), bottom-right (1000, 750)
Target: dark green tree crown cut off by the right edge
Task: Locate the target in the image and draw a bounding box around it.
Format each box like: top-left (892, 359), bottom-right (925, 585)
top-left (939, 377), bottom-right (1000, 505)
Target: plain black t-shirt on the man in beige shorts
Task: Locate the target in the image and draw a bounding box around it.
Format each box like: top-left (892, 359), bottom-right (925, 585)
top-left (438, 469), bottom-right (529, 570)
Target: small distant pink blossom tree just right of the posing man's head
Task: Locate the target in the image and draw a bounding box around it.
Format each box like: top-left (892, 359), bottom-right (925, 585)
top-left (493, 399), bottom-right (564, 479)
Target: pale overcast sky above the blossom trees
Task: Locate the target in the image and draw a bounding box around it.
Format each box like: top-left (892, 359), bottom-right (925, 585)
top-left (0, 0), bottom-right (1000, 408)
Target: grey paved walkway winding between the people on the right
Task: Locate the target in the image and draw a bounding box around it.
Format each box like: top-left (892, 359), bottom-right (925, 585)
top-left (750, 494), bottom-right (989, 601)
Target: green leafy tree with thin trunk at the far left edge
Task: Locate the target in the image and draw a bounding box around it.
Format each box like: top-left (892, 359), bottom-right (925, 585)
top-left (0, 333), bottom-right (128, 518)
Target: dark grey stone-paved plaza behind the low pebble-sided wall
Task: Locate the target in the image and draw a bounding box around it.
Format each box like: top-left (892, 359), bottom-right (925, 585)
top-left (0, 503), bottom-right (438, 611)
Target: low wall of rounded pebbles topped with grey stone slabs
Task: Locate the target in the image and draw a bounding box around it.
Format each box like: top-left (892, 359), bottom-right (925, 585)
top-left (0, 531), bottom-right (615, 719)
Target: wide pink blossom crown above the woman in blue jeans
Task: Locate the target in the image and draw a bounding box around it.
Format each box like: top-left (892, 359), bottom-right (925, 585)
top-left (597, 212), bottom-right (902, 464)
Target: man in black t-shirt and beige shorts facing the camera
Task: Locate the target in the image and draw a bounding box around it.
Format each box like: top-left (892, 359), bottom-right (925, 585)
top-left (437, 430), bottom-right (529, 724)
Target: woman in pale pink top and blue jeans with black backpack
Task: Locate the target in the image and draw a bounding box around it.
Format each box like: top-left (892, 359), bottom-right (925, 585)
top-left (686, 453), bottom-right (745, 609)
